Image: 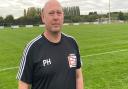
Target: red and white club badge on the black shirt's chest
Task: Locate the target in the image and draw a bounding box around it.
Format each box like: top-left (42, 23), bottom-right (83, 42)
top-left (68, 54), bottom-right (77, 68)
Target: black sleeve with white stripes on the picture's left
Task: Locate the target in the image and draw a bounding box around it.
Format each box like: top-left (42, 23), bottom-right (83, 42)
top-left (16, 44), bottom-right (33, 84)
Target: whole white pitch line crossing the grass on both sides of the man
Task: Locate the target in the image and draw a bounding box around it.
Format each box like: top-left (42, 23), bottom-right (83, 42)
top-left (0, 49), bottom-right (128, 72)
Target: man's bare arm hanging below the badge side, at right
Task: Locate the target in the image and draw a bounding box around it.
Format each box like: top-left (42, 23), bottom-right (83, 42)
top-left (76, 68), bottom-right (84, 89)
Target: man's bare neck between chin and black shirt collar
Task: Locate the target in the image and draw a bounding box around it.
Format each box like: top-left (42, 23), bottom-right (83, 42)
top-left (44, 31), bottom-right (61, 43)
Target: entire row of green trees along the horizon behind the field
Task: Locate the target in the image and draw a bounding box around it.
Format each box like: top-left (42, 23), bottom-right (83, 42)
top-left (0, 6), bottom-right (128, 26)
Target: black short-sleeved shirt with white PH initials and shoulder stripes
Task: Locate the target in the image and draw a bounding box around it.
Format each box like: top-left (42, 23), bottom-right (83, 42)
top-left (17, 34), bottom-right (81, 89)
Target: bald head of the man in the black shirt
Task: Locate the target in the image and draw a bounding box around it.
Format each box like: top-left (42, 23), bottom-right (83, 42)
top-left (41, 0), bottom-right (64, 32)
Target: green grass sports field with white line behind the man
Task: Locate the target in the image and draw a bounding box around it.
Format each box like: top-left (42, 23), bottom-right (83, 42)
top-left (0, 24), bottom-right (128, 89)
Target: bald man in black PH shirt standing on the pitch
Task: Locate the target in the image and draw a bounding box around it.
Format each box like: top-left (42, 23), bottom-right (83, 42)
top-left (17, 0), bottom-right (83, 89)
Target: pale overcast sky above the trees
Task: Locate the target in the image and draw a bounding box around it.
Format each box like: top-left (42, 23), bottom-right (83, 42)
top-left (0, 0), bottom-right (128, 18)
